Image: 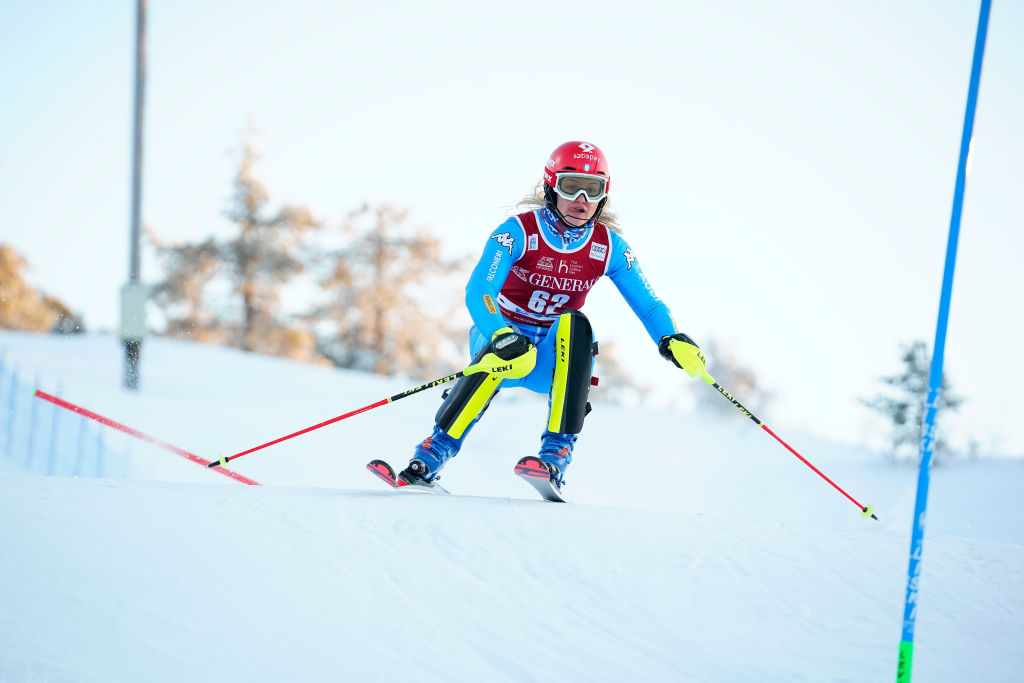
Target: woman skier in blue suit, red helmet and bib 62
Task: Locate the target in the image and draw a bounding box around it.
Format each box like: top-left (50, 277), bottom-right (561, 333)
top-left (398, 141), bottom-right (714, 498)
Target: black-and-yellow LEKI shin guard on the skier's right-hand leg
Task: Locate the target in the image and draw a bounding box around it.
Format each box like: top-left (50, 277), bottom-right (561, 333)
top-left (548, 310), bottom-right (594, 434)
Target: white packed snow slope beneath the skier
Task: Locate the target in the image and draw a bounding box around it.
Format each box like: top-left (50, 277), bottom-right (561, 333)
top-left (0, 333), bottom-right (1024, 682)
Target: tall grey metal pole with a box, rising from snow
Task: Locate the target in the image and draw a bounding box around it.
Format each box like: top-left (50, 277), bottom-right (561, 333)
top-left (120, 0), bottom-right (148, 391)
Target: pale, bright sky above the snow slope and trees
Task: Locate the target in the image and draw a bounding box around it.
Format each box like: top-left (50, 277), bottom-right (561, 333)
top-left (0, 0), bottom-right (1024, 456)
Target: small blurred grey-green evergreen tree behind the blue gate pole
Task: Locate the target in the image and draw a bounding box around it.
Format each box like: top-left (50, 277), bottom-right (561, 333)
top-left (860, 340), bottom-right (964, 463)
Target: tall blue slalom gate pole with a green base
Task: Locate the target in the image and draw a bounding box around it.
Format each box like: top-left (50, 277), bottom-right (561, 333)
top-left (896, 0), bottom-right (992, 683)
